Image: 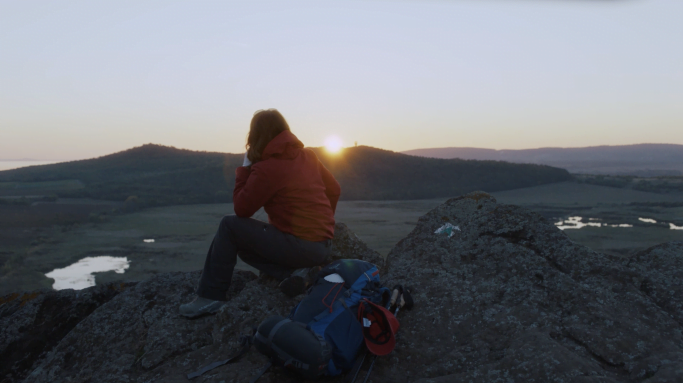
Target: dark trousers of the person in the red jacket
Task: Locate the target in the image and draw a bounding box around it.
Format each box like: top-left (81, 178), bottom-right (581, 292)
top-left (197, 215), bottom-right (331, 301)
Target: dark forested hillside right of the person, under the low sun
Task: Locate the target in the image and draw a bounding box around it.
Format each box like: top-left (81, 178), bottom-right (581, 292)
top-left (316, 146), bottom-right (572, 200)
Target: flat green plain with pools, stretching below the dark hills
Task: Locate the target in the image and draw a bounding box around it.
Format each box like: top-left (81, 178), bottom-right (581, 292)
top-left (0, 183), bottom-right (683, 293)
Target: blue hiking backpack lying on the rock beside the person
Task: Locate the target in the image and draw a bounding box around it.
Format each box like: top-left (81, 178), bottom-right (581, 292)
top-left (254, 259), bottom-right (390, 378)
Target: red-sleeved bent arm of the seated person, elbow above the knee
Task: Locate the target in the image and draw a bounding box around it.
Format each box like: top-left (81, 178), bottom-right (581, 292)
top-left (232, 164), bottom-right (276, 218)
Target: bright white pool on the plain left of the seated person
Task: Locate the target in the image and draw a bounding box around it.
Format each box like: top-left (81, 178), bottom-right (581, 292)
top-left (45, 255), bottom-right (130, 290)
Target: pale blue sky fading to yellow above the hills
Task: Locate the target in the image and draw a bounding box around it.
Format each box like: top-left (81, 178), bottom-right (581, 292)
top-left (0, 0), bottom-right (683, 160)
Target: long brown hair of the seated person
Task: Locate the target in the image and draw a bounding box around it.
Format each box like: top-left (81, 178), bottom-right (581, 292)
top-left (246, 109), bottom-right (289, 163)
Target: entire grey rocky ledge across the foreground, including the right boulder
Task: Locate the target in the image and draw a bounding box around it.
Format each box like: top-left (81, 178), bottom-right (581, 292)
top-left (0, 193), bottom-right (683, 383)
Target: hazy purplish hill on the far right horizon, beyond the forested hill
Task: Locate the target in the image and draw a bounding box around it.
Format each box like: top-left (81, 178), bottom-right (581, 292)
top-left (402, 144), bottom-right (683, 177)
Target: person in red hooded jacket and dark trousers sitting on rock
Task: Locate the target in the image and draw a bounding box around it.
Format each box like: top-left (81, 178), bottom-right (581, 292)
top-left (180, 109), bottom-right (341, 318)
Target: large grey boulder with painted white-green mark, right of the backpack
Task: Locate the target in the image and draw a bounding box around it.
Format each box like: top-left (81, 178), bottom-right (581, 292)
top-left (376, 192), bottom-right (683, 383)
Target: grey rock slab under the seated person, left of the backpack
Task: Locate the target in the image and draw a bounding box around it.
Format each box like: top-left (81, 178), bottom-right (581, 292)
top-left (0, 224), bottom-right (382, 383)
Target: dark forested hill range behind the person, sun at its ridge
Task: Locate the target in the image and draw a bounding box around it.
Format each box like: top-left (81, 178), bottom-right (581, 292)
top-left (0, 144), bottom-right (572, 206)
